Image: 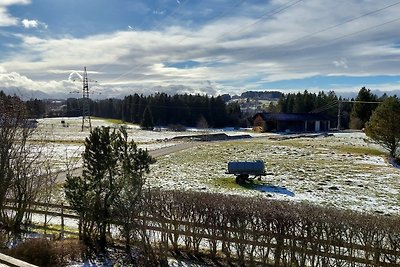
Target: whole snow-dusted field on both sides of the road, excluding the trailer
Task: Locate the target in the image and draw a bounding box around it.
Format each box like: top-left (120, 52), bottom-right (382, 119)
top-left (38, 118), bottom-right (400, 215)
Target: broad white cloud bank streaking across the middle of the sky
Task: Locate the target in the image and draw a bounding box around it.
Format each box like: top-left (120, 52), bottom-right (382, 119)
top-left (0, 0), bottom-right (400, 98)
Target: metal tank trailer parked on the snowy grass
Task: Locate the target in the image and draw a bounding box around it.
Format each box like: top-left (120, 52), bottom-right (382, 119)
top-left (226, 160), bottom-right (267, 184)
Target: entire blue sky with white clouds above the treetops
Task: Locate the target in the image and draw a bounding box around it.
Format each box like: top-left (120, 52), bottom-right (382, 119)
top-left (0, 0), bottom-right (400, 98)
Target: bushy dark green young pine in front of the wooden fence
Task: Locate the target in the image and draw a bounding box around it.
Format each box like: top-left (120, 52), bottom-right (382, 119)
top-left (65, 127), bottom-right (154, 251)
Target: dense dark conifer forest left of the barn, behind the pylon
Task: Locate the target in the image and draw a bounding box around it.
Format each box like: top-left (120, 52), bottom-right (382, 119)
top-left (61, 93), bottom-right (241, 128)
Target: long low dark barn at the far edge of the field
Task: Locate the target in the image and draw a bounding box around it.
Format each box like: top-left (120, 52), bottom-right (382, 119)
top-left (253, 112), bottom-right (330, 133)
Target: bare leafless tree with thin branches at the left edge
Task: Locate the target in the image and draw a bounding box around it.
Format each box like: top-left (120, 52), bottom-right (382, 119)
top-left (0, 92), bottom-right (56, 231)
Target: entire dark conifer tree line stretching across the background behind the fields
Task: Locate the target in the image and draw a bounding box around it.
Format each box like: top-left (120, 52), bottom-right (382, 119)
top-left (20, 87), bottom-right (398, 133)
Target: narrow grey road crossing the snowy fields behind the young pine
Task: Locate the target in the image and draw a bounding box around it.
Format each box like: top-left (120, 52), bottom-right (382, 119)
top-left (56, 142), bottom-right (202, 183)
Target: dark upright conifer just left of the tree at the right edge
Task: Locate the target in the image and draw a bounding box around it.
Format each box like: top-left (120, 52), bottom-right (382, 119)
top-left (350, 87), bottom-right (378, 129)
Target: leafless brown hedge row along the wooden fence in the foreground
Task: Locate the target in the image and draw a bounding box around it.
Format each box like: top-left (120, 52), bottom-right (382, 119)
top-left (137, 190), bottom-right (400, 266)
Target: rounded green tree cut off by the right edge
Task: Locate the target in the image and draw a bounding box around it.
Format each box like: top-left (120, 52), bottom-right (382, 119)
top-left (365, 97), bottom-right (400, 157)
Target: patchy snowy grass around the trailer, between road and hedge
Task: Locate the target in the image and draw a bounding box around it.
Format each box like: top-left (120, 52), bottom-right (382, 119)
top-left (149, 136), bottom-right (400, 214)
